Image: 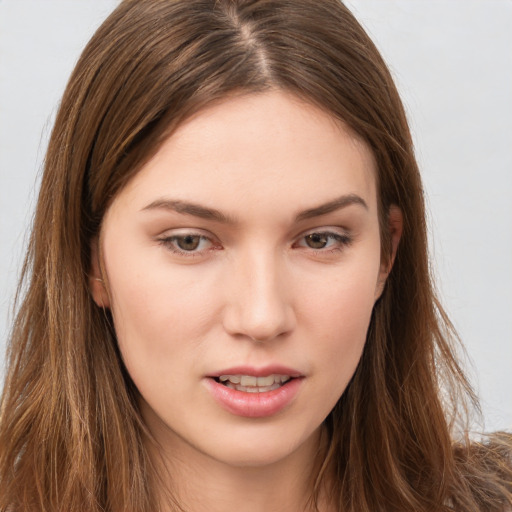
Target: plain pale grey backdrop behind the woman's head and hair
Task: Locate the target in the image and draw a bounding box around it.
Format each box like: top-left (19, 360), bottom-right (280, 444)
top-left (0, 0), bottom-right (512, 429)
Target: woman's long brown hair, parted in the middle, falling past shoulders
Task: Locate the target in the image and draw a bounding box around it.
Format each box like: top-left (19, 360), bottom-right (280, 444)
top-left (0, 0), bottom-right (512, 512)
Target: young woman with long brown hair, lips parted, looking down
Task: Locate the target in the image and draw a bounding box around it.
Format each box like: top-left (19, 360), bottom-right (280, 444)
top-left (0, 0), bottom-right (512, 512)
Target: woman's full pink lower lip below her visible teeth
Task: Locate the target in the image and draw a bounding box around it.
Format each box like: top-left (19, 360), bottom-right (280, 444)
top-left (206, 378), bottom-right (302, 418)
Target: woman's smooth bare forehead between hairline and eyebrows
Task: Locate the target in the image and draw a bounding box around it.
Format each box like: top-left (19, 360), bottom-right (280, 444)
top-left (114, 91), bottom-right (376, 219)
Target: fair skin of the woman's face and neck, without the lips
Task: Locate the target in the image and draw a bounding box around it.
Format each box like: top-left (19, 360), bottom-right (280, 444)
top-left (91, 91), bottom-right (401, 512)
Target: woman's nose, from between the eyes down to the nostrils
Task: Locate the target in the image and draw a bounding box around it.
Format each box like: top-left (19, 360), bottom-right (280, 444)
top-left (223, 251), bottom-right (296, 342)
